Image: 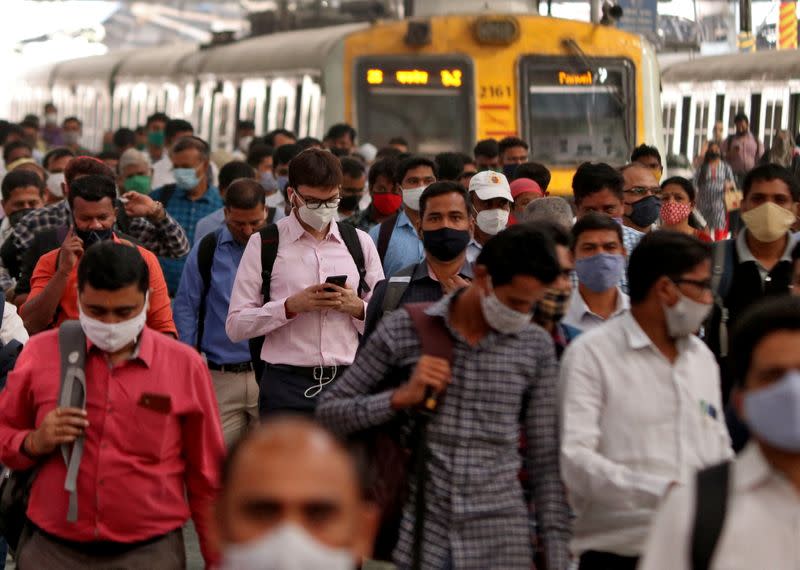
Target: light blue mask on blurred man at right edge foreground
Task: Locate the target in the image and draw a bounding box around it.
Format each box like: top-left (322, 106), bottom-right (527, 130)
top-left (744, 370), bottom-right (800, 453)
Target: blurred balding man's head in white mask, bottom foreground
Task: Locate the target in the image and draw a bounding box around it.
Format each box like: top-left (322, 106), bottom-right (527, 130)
top-left (216, 417), bottom-right (377, 570)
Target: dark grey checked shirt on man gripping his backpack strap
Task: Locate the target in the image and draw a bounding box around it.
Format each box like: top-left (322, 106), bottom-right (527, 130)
top-left (317, 295), bottom-right (570, 570)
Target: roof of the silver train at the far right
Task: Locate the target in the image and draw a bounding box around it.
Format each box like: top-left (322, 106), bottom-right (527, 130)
top-left (661, 50), bottom-right (800, 83)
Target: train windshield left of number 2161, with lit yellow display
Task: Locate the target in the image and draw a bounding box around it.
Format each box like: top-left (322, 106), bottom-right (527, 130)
top-left (356, 57), bottom-right (475, 155)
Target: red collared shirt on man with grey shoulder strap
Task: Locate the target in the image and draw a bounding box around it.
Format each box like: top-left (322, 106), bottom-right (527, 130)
top-left (0, 327), bottom-right (225, 562)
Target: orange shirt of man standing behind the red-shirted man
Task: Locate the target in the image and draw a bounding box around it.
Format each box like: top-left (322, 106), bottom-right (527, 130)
top-left (21, 235), bottom-right (177, 334)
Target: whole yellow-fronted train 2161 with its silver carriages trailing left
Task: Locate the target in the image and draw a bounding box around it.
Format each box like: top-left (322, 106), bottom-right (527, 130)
top-left (12, 13), bottom-right (664, 194)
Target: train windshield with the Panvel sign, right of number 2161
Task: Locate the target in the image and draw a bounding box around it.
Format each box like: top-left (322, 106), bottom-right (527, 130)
top-left (521, 56), bottom-right (636, 166)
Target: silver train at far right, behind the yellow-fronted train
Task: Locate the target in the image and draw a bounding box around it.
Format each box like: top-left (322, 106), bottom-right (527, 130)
top-left (662, 50), bottom-right (800, 165)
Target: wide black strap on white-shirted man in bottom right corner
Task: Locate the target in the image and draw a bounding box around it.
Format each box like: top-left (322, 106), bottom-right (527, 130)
top-left (692, 462), bottom-right (731, 570)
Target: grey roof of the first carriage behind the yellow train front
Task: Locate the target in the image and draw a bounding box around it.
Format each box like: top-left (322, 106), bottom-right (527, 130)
top-left (199, 24), bottom-right (368, 75)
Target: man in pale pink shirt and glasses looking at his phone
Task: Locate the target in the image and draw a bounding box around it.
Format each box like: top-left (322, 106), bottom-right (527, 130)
top-left (225, 149), bottom-right (383, 415)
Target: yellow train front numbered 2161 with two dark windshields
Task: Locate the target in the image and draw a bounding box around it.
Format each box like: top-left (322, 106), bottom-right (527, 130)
top-left (343, 15), bottom-right (663, 194)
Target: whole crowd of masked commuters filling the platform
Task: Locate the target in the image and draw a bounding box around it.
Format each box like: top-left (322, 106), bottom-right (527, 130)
top-left (0, 105), bottom-right (800, 570)
